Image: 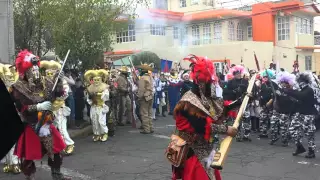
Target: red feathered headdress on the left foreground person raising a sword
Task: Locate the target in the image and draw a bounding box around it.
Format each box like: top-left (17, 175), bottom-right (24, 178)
top-left (16, 50), bottom-right (40, 77)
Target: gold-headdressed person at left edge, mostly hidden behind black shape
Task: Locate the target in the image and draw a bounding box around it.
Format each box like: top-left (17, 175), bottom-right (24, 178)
top-left (0, 64), bottom-right (21, 174)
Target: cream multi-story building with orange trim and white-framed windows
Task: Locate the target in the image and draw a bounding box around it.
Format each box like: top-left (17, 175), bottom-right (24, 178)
top-left (105, 0), bottom-right (320, 71)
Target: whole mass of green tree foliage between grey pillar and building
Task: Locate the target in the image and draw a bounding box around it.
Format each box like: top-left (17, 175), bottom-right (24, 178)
top-left (14, 0), bottom-right (151, 69)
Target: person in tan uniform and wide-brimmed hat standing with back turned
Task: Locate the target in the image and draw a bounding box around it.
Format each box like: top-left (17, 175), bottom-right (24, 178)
top-left (137, 64), bottom-right (154, 134)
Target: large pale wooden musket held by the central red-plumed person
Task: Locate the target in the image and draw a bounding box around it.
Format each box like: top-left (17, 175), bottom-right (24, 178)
top-left (210, 74), bottom-right (257, 170)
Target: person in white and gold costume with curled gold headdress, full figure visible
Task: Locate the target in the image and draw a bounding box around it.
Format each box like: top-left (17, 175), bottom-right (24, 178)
top-left (84, 70), bottom-right (109, 142)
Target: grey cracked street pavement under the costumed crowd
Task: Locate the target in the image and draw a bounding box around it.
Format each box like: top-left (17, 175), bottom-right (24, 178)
top-left (0, 116), bottom-right (320, 180)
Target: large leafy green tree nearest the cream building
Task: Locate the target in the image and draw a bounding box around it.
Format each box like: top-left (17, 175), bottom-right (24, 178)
top-left (40, 0), bottom-right (149, 69)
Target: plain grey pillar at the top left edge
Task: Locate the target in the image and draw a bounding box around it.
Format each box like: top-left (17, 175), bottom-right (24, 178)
top-left (0, 0), bottom-right (15, 64)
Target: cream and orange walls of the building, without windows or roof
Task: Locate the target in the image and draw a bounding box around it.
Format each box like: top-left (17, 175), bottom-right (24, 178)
top-left (110, 0), bottom-right (320, 71)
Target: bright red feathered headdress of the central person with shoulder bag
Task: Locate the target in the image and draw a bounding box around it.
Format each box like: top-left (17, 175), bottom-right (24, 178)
top-left (184, 54), bottom-right (218, 84)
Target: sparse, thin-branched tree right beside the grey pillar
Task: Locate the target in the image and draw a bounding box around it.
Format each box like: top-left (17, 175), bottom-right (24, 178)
top-left (13, 0), bottom-right (54, 56)
